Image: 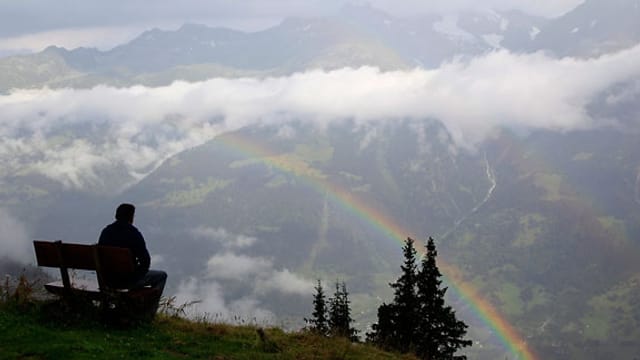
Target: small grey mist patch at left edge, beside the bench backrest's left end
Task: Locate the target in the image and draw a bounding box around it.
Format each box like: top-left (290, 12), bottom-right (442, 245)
top-left (0, 208), bottom-right (34, 264)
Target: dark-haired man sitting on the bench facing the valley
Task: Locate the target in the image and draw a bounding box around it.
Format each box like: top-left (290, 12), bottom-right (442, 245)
top-left (98, 204), bottom-right (167, 302)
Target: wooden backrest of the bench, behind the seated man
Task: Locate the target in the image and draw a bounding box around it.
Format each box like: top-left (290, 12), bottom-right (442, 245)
top-left (33, 240), bottom-right (135, 290)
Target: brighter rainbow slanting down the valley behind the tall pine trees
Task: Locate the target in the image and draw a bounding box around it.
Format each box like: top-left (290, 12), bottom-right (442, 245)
top-left (215, 133), bottom-right (536, 360)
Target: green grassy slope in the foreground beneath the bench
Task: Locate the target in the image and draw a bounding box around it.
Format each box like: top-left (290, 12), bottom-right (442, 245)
top-left (0, 278), bottom-right (413, 360)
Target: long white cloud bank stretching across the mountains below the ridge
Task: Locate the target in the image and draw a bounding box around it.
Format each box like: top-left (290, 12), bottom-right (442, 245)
top-left (0, 46), bottom-right (640, 187)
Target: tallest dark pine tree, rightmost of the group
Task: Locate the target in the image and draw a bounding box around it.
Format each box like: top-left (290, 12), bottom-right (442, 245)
top-left (415, 238), bottom-right (472, 360)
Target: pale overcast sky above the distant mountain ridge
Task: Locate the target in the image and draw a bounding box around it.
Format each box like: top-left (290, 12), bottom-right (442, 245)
top-left (0, 0), bottom-right (583, 56)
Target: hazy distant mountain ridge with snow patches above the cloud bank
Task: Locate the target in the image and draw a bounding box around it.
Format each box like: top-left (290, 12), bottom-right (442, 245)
top-left (0, 0), bottom-right (640, 93)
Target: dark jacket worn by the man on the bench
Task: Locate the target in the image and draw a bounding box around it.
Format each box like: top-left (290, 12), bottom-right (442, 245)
top-left (98, 220), bottom-right (151, 282)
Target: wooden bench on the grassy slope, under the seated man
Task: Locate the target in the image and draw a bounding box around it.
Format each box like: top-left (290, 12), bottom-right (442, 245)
top-left (33, 240), bottom-right (160, 318)
